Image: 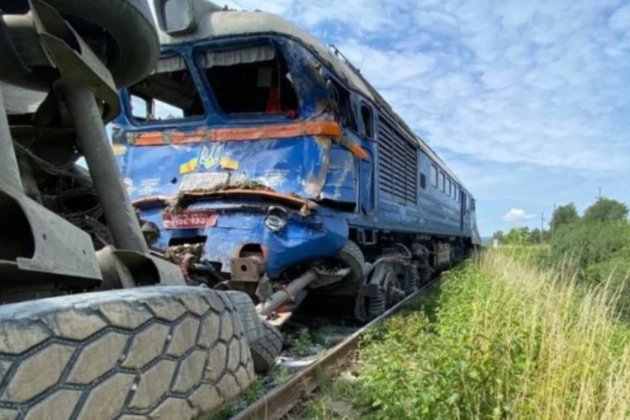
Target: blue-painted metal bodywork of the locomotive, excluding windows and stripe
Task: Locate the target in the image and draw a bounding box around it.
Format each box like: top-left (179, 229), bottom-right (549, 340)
top-left (117, 34), bottom-right (476, 277)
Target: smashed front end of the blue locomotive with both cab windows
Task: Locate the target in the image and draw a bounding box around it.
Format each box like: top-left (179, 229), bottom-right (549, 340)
top-left (112, 21), bottom-right (368, 332)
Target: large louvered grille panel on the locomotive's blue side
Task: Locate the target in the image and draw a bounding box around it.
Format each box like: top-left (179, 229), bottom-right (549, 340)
top-left (378, 117), bottom-right (418, 204)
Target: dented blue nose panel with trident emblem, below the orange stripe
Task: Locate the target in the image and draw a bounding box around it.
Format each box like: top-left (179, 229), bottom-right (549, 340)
top-left (119, 137), bottom-right (334, 201)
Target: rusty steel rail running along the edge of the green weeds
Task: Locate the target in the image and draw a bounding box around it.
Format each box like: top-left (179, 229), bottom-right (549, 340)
top-left (231, 282), bottom-right (434, 420)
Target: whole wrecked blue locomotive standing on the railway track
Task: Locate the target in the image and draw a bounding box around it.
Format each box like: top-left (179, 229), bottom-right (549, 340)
top-left (112, 0), bottom-right (479, 324)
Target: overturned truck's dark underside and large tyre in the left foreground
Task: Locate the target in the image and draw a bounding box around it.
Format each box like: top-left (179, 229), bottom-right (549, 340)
top-left (0, 0), bottom-right (265, 419)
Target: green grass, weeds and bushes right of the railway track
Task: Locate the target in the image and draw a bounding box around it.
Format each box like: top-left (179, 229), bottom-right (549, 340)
top-left (227, 198), bottom-right (630, 419)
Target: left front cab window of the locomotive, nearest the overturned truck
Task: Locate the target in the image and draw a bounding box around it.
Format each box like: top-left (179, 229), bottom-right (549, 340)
top-left (128, 54), bottom-right (205, 123)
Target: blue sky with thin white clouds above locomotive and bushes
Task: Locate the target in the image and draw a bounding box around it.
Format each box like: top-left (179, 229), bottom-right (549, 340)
top-left (220, 0), bottom-right (630, 236)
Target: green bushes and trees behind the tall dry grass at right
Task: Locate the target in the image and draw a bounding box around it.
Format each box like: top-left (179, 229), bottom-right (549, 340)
top-left (493, 198), bottom-right (630, 316)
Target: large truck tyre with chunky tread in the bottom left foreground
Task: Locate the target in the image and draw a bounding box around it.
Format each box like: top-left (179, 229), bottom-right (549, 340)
top-left (0, 286), bottom-right (253, 419)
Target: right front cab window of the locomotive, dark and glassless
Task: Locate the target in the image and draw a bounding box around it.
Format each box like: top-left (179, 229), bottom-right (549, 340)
top-left (202, 44), bottom-right (298, 116)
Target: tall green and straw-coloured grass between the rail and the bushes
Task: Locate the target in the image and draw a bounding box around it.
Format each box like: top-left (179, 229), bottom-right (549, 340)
top-left (307, 251), bottom-right (630, 419)
